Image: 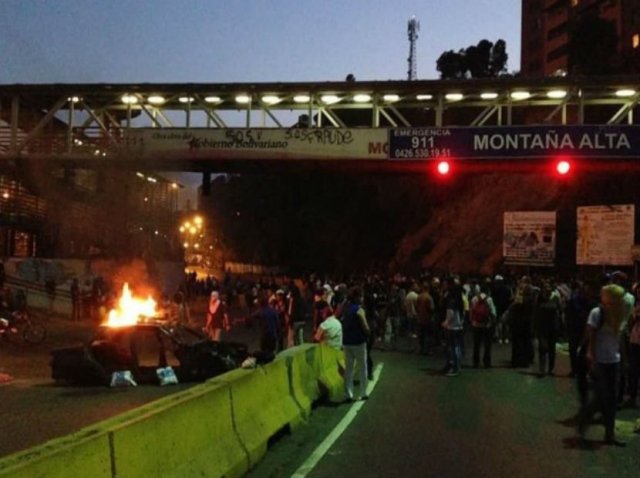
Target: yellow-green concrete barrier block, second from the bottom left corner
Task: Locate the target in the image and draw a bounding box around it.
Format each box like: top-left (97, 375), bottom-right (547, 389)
top-left (111, 382), bottom-right (249, 478)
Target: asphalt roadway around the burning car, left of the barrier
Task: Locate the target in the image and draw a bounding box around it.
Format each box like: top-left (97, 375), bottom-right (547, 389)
top-left (0, 310), bottom-right (258, 457)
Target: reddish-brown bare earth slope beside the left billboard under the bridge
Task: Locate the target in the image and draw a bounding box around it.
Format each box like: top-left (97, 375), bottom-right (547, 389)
top-left (394, 174), bottom-right (561, 274)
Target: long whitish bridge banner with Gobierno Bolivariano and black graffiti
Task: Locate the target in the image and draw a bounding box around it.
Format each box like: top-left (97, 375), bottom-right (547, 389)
top-left (125, 128), bottom-right (388, 160)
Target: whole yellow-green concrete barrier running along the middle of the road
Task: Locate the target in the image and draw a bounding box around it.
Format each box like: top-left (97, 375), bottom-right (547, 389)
top-left (0, 344), bottom-right (344, 478)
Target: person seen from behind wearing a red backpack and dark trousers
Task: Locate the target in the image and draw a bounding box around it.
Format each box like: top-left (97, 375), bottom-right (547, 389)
top-left (469, 287), bottom-right (496, 368)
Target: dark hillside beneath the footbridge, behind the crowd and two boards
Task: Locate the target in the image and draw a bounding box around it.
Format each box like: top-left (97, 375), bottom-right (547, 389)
top-left (205, 168), bottom-right (640, 273)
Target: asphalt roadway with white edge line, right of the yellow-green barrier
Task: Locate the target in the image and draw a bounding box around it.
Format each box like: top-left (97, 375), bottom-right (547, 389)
top-left (249, 336), bottom-right (640, 478)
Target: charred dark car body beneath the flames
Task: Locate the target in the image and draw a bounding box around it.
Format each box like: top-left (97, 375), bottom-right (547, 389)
top-left (51, 322), bottom-right (248, 385)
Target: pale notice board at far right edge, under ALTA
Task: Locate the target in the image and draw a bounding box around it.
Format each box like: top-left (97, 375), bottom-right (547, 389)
top-left (576, 204), bottom-right (635, 266)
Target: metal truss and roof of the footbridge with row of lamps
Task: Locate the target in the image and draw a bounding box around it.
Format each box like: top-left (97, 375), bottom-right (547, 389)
top-left (0, 76), bottom-right (640, 164)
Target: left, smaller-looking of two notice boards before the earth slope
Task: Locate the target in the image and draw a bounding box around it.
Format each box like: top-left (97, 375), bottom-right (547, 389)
top-left (502, 211), bottom-right (556, 267)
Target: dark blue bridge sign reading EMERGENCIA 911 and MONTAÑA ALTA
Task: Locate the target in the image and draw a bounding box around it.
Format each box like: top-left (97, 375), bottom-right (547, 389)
top-left (389, 125), bottom-right (640, 160)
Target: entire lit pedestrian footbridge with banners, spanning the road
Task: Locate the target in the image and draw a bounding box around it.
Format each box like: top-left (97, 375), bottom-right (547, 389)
top-left (0, 76), bottom-right (640, 176)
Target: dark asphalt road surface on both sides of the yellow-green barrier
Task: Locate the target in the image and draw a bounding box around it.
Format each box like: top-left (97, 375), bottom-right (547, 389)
top-left (0, 314), bottom-right (640, 478)
